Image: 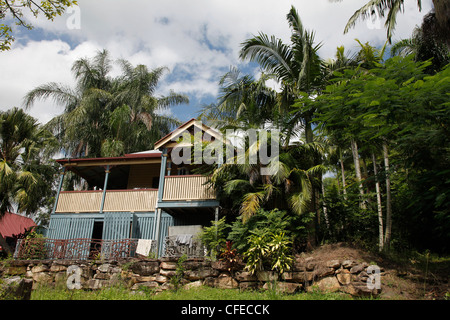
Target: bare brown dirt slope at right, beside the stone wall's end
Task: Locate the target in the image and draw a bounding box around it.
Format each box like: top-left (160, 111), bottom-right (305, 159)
top-left (301, 243), bottom-right (450, 300)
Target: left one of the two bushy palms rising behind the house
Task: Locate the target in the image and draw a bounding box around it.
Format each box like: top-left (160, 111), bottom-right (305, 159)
top-left (24, 50), bottom-right (112, 156)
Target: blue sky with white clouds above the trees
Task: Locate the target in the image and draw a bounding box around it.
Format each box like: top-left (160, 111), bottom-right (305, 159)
top-left (0, 0), bottom-right (432, 123)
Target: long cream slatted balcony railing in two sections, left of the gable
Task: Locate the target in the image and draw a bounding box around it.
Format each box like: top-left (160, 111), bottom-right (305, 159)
top-left (55, 189), bottom-right (158, 213)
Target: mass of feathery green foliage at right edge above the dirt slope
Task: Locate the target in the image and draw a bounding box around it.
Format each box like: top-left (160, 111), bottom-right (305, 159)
top-left (296, 52), bottom-right (450, 250)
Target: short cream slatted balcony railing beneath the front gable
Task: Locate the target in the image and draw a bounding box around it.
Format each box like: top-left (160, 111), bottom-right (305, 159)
top-left (163, 175), bottom-right (216, 201)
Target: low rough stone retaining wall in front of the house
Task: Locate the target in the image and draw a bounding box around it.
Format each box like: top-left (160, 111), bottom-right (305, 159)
top-left (0, 258), bottom-right (382, 296)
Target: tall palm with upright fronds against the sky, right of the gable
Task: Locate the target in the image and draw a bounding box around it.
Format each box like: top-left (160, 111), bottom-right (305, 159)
top-left (240, 7), bottom-right (324, 143)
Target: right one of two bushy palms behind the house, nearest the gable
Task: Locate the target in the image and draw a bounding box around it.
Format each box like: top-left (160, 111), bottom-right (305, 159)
top-left (106, 60), bottom-right (189, 156)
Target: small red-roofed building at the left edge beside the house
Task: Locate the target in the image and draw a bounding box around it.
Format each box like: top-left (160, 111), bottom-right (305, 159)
top-left (0, 212), bottom-right (37, 254)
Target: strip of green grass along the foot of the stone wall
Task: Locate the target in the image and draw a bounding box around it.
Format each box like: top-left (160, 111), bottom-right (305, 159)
top-left (31, 286), bottom-right (352, 300)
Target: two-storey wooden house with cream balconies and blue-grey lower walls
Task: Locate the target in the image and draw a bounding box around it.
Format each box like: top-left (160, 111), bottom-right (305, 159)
top-left (43, 119), bottom-right (221, 257)
